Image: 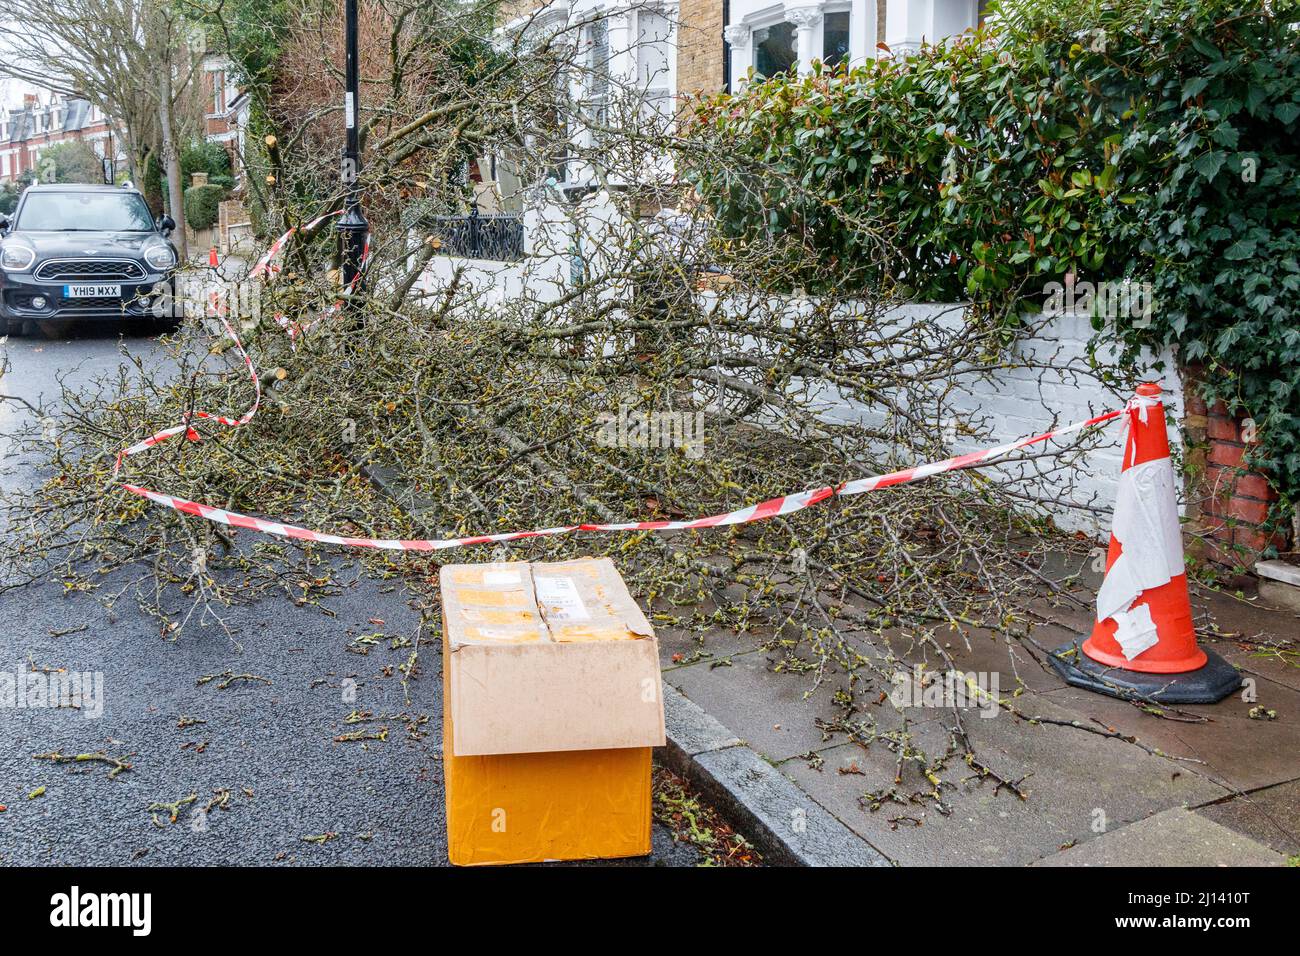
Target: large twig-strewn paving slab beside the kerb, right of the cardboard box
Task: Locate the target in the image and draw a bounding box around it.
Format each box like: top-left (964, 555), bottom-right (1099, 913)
top-left (780, 698), bottom-right (1227, 865)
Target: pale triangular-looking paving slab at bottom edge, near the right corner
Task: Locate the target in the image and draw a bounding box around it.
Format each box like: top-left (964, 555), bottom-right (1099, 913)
top-left (1035, 809), bottom-right (1286, 866)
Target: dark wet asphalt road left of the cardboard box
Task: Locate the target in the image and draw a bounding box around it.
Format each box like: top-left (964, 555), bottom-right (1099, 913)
top-left (0, 329), bottom-right (698, 866)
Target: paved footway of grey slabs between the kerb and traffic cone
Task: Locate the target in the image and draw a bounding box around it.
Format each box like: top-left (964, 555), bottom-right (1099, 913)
top-left (660, 558), bottom-right (1300, 866)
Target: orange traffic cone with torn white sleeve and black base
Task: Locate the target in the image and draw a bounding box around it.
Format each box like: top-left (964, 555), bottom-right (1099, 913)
top-left (1050, 382), bottom-right (1242, 704)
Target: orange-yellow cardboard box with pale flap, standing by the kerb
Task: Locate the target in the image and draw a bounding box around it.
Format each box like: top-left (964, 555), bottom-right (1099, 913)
top-left (441, 558), bottom-right (664, 865)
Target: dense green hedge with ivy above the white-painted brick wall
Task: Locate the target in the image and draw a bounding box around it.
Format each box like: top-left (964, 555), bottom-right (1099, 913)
top-left (684, 0), bottom-right (1300, 522)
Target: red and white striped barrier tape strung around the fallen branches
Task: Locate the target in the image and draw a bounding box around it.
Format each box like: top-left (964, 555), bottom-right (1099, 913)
top-left (113, 211), bottom-right (1128, 551)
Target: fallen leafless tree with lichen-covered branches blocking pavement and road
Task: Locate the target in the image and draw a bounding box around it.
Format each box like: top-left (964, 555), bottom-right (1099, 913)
top-left (4, 0), bottom-right (1175, 809)
